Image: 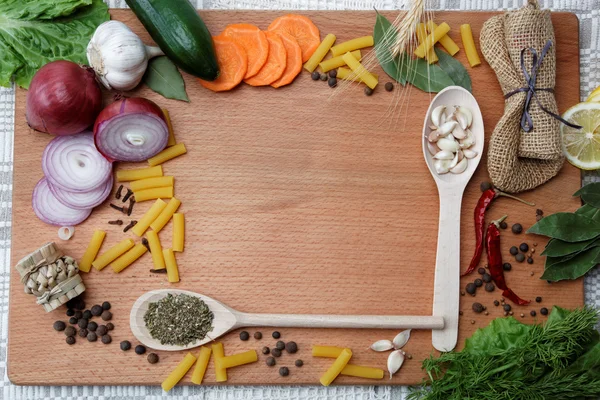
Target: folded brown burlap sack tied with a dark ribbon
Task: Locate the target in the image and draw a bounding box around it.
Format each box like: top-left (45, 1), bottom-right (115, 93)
top-left (480, 0), bottom-right (564, 193)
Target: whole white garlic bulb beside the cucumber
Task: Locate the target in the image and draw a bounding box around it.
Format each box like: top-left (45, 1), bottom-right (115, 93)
top-left (87, 21), bottom-right (164, 90)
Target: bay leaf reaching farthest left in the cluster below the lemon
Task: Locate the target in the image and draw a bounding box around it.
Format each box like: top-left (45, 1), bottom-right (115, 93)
top-left (527, 212), bottom-right (600, 242)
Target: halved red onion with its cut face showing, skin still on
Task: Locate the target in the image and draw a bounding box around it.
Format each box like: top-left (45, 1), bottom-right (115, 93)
top-left (94, 97), bottom-right (169, 162)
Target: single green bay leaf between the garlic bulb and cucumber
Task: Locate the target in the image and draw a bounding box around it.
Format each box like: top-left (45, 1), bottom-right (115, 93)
top-left (143, 56), bottom-right (190, 103)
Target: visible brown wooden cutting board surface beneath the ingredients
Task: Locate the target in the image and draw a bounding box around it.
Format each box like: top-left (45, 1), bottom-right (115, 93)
top-left (8, 10), bottom-right (583, 385)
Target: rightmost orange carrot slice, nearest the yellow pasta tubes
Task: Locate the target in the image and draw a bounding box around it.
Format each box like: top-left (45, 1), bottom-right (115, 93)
top-left (269, 14), bottom-right (321, 62)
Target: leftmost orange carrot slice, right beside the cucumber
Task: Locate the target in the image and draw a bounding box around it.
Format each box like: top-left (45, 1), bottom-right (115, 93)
top-left (198, 36), bottom-right (248, 92)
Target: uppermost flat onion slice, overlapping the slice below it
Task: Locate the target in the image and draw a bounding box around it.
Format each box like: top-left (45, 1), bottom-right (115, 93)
top-left (42, 132), bottom-right (112, 193)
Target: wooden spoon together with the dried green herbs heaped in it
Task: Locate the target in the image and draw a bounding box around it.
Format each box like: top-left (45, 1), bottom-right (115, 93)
top-left (129, 289), bottom-right (444, 351)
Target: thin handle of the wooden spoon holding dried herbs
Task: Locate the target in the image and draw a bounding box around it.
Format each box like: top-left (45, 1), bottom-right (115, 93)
top-left (236, 313), bottom-right (444, 329)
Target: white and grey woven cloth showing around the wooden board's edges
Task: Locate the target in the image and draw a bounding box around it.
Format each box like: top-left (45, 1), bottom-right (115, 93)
top-left (0, 0), bottom-right (600, 400)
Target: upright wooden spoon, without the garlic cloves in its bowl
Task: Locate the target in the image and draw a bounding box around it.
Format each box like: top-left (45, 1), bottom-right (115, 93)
top-left (422, 86), bottom-right (484, 352)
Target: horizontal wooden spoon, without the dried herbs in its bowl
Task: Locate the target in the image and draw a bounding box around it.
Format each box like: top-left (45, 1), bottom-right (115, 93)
top-left (129, 289), bottom-right (444, 351)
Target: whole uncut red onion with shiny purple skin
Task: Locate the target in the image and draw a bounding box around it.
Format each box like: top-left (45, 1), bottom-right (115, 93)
top-left (25, 60), bottom-right (102, 135)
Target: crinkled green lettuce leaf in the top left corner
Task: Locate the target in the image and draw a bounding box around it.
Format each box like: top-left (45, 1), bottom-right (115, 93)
top-left (0, 0), bottom-right (110, 88)
